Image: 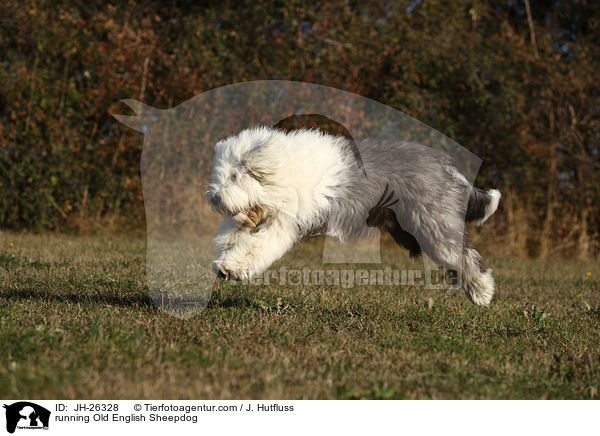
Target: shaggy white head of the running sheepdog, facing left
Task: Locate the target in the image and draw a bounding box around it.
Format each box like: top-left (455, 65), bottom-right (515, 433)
top-left (207, 128), bottom-right (280, 217)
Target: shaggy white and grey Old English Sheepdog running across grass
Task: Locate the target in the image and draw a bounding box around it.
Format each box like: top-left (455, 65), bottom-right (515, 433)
top-left (207, 127), bottom-right (500, 306)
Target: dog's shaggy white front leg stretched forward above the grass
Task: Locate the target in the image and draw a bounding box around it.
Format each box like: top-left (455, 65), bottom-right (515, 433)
top-left (213, 218), bottom-right (298, 280)
